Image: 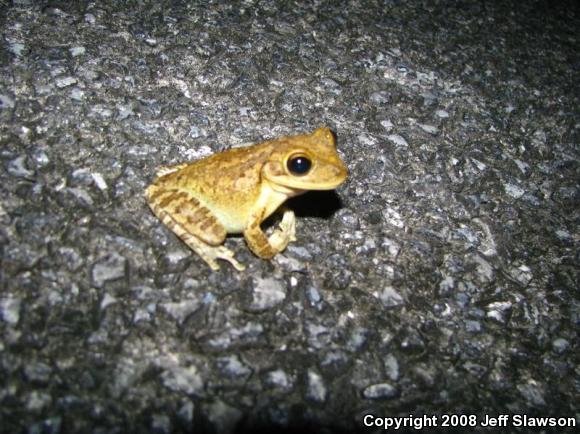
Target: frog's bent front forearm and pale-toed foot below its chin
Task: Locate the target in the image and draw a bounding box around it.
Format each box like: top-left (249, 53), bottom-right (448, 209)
top-left (244, 209), bottom-right (296, 259)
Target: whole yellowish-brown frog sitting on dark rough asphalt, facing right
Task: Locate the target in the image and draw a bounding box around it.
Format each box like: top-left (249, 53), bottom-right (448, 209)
top-left (145, 127), bottom-right (348, 271)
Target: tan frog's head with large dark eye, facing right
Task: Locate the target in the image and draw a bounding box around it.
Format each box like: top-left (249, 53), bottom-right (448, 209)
top-left (262, 128), bottom-right (348, 190)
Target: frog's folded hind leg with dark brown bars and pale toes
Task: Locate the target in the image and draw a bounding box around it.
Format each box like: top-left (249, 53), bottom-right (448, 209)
top-left (146, 184), bottom-right (245, 270)
